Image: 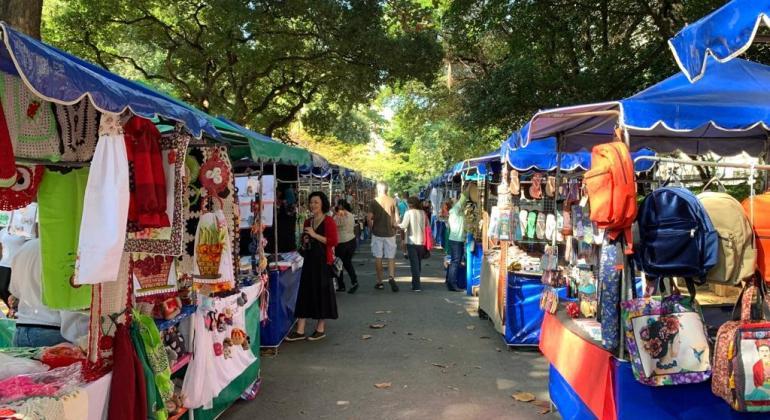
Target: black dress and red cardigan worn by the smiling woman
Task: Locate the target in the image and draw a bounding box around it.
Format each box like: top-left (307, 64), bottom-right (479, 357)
top-left (294, 216), bottom-right (337, 319)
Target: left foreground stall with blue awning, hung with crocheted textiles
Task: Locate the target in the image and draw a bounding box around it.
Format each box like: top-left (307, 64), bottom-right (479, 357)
top-left (0, 24), bottom-right (270, 419)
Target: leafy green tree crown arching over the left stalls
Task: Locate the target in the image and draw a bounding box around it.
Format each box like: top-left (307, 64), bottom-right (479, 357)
top-left (43, 0), bottom-right (443, 137)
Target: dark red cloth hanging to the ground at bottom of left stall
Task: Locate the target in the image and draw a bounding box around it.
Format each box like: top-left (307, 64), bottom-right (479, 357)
top-left (107, 324), bottom-right (147, 420)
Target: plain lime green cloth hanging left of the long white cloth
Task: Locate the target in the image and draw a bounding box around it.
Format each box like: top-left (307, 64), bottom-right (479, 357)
top-left (37, 168), bottom-right (91, 311)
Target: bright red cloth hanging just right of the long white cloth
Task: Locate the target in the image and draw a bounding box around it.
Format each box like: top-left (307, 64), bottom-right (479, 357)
top-left (124, 117), bottom-right (171, 232)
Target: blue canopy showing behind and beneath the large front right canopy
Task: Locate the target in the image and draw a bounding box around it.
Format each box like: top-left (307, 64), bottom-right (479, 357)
top-left (502, 133), bottom-right (655, 172)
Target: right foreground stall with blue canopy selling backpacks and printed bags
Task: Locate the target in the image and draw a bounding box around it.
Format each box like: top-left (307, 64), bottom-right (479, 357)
top-left (519, 54), bottom-right (770, 419)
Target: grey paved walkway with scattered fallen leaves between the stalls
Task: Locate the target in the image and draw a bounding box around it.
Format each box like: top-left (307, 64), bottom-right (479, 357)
top-left (223, 246), bottom-right (556, 420)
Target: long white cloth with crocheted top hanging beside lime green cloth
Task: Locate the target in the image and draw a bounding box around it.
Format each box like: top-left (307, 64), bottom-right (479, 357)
top-left (75, 114), bottom-right (129, 284)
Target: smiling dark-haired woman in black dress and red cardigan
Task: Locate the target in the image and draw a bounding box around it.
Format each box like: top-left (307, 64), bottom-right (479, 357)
top-left (286, 191), bottom-right (337, 341)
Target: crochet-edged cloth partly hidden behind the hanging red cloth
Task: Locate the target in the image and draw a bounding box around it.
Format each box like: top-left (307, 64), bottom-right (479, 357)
top-left (125, 130), bottom-right (190, 256)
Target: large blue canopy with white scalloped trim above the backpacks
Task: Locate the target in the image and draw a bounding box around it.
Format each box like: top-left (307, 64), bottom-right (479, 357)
top-left (519, 58), bottom-right (770, 155)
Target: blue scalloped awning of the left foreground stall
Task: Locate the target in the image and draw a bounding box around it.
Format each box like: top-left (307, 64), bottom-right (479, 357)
top-left (0, 23), bottom-right (219, 138)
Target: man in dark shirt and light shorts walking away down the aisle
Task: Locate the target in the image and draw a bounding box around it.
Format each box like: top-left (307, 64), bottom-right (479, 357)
top-left (369, 182), bottom-right (400, 292)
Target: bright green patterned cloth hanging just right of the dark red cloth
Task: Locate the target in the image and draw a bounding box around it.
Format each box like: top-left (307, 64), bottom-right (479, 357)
top-left (133, 311), bottom-right (174, 412)
